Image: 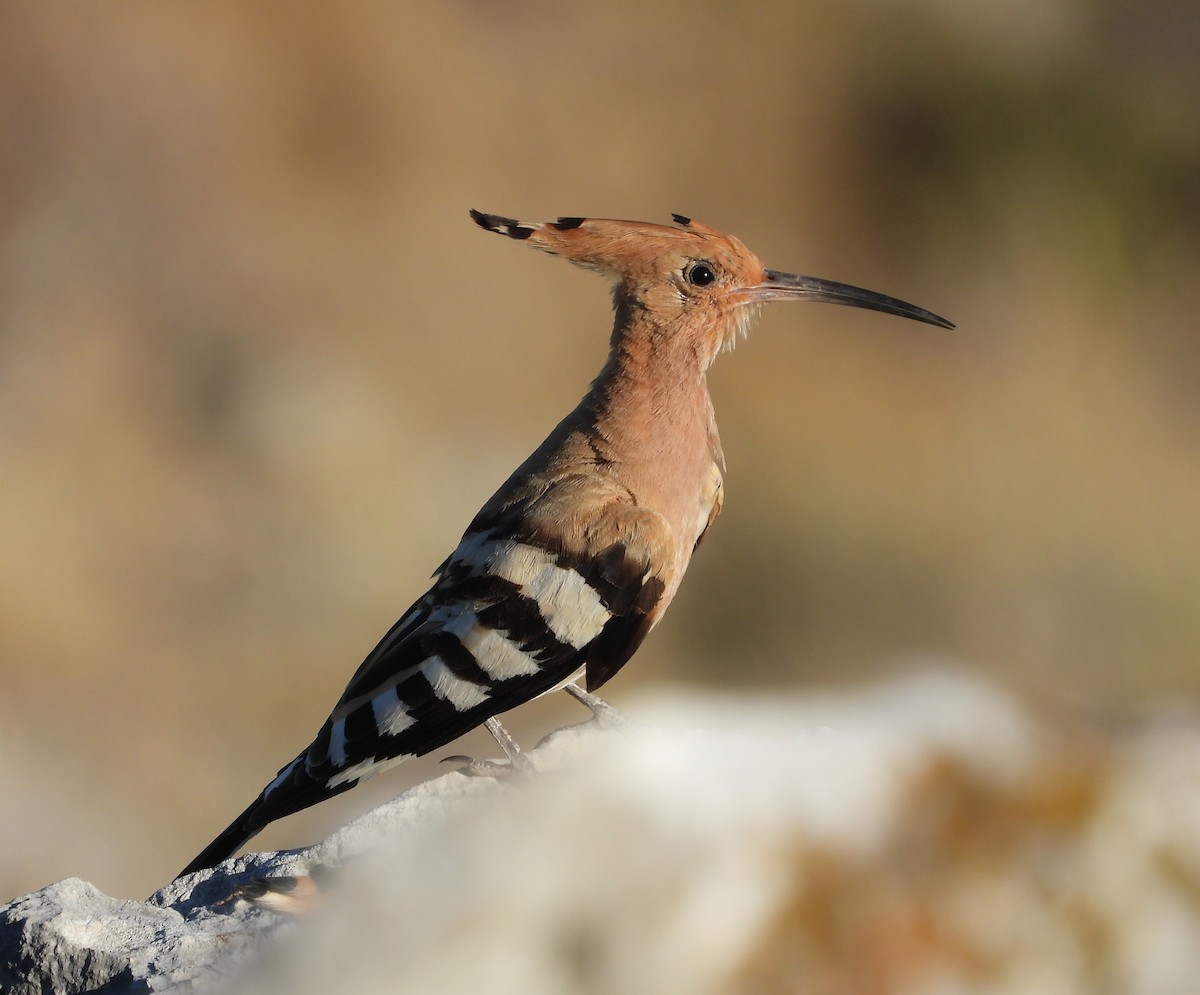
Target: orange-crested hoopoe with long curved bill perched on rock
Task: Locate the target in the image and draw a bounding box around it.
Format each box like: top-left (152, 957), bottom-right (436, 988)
top-left (174, 210), bottom-right (953, 875)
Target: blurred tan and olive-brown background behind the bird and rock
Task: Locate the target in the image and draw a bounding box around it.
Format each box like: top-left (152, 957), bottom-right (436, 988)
top-left (0, 0), bottom-right (1200, 900)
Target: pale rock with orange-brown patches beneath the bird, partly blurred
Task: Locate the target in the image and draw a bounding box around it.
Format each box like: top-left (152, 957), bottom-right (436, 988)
top-left (0, 675), bottom-right (1200, 995)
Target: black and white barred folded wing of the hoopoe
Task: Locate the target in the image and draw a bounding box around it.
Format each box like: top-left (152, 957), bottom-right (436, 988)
top-left (264, 532), bottom-right (662, 819)
